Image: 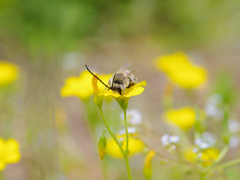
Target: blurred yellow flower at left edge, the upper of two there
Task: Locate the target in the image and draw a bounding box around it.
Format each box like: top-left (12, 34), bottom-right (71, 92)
top-left (0, 61), bottom-right (18, 86)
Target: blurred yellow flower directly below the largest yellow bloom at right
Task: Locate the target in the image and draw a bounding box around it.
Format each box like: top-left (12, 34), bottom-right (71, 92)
top-left (164, 107), bottom-right (199, 129)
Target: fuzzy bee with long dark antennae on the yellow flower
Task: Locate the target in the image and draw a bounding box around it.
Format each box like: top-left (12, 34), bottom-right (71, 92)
top-left (85, 63), bottom-right (137, 95)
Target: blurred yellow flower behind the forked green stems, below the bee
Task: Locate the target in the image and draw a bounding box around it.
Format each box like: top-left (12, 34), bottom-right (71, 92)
top-left (106, 134), bottom-right (144, 158)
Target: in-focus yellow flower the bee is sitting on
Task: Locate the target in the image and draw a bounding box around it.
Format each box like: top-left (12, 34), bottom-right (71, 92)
top-left (101, 81), bottom-right (147, 109)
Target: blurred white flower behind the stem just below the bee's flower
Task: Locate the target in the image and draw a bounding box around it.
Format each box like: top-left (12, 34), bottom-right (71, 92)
top-left (120, 109), bottom-right (142, 126)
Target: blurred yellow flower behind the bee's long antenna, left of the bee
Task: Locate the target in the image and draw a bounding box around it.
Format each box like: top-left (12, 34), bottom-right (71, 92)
top-left (61, 70), bottom-right (112, 99)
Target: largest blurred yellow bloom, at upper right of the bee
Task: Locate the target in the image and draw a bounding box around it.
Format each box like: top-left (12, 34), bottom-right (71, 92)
top-left (156, 52), bottom-right (207, 89)
